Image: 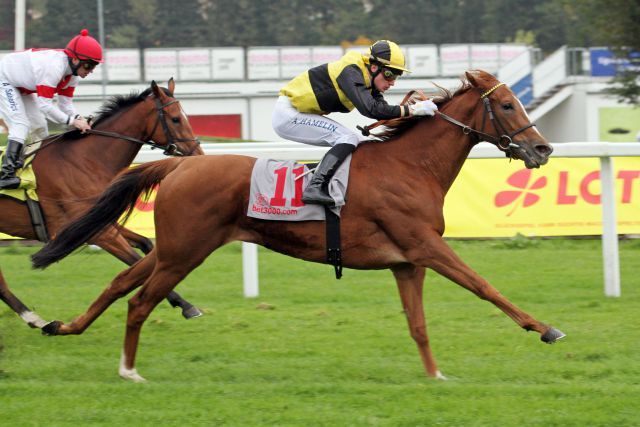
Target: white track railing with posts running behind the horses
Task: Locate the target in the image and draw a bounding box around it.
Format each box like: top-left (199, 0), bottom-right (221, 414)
top-left (136, 142), bottom-right (640, 298)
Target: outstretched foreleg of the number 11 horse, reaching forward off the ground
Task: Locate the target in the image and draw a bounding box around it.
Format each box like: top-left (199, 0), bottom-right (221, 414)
top-left (419, 236), bottom-right (565, 343)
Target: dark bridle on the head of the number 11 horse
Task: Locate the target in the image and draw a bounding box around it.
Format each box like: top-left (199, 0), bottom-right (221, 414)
top-left (436, 83), bottom-right (536, 157)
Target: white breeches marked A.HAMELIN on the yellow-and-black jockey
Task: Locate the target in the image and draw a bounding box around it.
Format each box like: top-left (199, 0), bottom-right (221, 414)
top-left (271, 96), bottom-right (360, 147)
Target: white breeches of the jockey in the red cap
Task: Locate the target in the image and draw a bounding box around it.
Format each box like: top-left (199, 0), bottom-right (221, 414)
top-left (0, 78), bottom-right (49, 143)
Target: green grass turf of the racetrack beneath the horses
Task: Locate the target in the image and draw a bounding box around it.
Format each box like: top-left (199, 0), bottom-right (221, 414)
top-left (0, 239), bottom-right (640, 426)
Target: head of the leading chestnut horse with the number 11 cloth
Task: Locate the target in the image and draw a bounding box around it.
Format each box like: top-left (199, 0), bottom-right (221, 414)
top-left (466, 70), bottom-right (553, 169)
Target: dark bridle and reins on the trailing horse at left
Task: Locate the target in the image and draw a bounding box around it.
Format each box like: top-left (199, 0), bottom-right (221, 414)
top-left (30, 97), bottom-right (200, 157)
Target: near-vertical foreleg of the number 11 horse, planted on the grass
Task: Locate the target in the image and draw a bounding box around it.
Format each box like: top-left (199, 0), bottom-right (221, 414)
top-left (391, 264), bottom-right (446, 380)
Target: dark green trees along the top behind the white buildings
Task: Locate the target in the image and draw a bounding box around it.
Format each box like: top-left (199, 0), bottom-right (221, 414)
top-left (0, 0), bottom-right (640, 103)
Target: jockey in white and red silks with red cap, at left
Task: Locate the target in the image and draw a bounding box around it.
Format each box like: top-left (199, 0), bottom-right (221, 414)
top-left (0, 30), bottom-right (102, 189)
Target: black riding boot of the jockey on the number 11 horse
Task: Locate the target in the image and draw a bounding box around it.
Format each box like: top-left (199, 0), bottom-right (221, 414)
top-left (302, 144), bottom-right (356, 205)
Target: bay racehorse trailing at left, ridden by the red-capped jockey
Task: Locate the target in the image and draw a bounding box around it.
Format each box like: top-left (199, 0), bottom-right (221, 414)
top-left (0, 79), bottom-right (203, 328)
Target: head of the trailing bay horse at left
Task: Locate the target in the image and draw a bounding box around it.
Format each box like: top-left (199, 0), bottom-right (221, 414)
top-left (147, 78), bottom-right (204, 156)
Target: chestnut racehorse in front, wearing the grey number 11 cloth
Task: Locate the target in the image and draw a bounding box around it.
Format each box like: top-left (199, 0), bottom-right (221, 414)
top-left (33, 71), bottom-right (564, 381)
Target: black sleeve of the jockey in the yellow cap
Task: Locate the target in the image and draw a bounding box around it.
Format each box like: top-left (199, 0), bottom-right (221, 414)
top-left (336, 64), bottom-right (406, 120)
